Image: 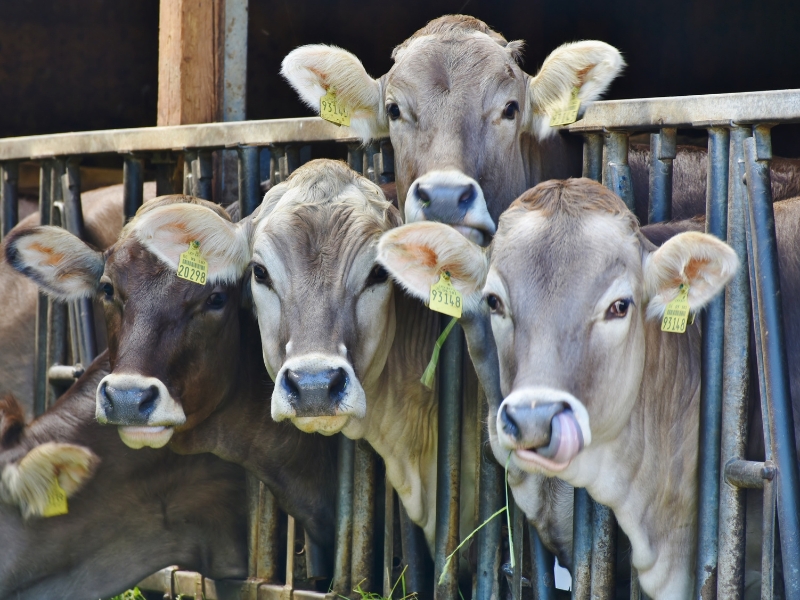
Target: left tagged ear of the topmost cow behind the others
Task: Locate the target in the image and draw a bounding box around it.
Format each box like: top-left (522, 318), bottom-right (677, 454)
top-left (281, 44), bottom-right (389, 141)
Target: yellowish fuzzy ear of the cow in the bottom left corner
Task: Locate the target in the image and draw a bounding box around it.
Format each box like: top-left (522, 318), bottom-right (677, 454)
top-left (0, 442), bottom-right (100, 519)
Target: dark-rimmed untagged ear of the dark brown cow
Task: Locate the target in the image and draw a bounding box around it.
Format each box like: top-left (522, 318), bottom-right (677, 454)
top-left (5, 226), bottom-right (105, 300)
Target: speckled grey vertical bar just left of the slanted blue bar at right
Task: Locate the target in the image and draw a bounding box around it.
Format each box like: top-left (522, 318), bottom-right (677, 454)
top-left (717, 127), bottom-right (750, 600)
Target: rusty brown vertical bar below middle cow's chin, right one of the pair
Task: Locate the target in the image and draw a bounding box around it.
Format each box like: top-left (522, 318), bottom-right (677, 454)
top-left (350, 443), bottom-right (377, 591)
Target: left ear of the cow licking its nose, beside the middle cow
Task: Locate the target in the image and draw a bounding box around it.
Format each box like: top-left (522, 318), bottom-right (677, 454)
top-left (378, 221), bottom-right (489, 312)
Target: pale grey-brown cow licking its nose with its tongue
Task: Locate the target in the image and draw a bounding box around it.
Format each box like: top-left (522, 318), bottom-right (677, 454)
top-left (379, 179), bottom-right (800, 599)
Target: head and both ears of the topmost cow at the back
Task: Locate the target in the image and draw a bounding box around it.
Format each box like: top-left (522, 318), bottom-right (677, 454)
top-left (281, 15), bottom-right (624, 244)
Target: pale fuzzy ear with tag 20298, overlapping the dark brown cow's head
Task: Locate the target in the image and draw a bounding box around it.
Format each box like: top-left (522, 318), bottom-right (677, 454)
top-left (131, 203), bottom-right (250, 283)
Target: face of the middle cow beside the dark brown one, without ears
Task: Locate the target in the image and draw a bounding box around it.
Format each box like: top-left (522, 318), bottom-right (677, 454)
top-left (251, 160), bottom-right (400, 434)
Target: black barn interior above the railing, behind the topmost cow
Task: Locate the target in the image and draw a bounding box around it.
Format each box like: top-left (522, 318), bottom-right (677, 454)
top-left (0, 0), bottom-right (800, 148)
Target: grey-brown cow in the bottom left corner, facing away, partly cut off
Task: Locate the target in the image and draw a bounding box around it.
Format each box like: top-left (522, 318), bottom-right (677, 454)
top-left (0, 360), bottom-right (247, 600)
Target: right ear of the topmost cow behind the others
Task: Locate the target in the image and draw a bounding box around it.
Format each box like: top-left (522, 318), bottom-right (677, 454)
top-left (528, 40), bottom-right (625, 139)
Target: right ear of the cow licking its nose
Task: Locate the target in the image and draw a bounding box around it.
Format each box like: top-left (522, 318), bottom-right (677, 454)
top-left (644, 232), bottom-right (739, 318)
